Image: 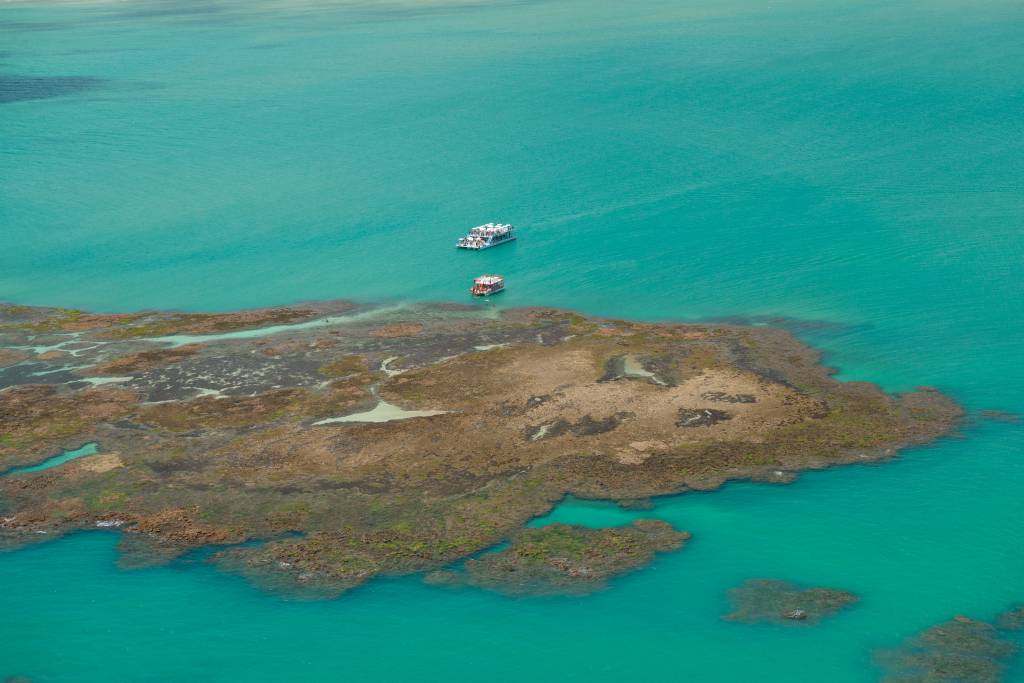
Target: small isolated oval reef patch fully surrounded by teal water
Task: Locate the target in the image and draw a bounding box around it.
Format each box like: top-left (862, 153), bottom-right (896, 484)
top-left (725, 579), bottom-right (858, 624)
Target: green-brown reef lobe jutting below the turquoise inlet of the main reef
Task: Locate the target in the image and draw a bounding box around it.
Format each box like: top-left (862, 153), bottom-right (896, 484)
top-left (427, 519), bottom-right (690, 595)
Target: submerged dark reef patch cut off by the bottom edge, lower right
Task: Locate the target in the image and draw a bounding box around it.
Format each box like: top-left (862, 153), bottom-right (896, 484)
top-left (879, 616), bottom-right (1017, 683)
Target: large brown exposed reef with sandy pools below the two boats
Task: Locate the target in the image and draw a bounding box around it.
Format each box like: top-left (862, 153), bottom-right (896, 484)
top-left (0, 302), bottom-right (962, 602)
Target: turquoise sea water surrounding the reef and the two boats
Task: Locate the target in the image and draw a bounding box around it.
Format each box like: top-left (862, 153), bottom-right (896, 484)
top-left (0, 0), bottom-right (1024, 683)
